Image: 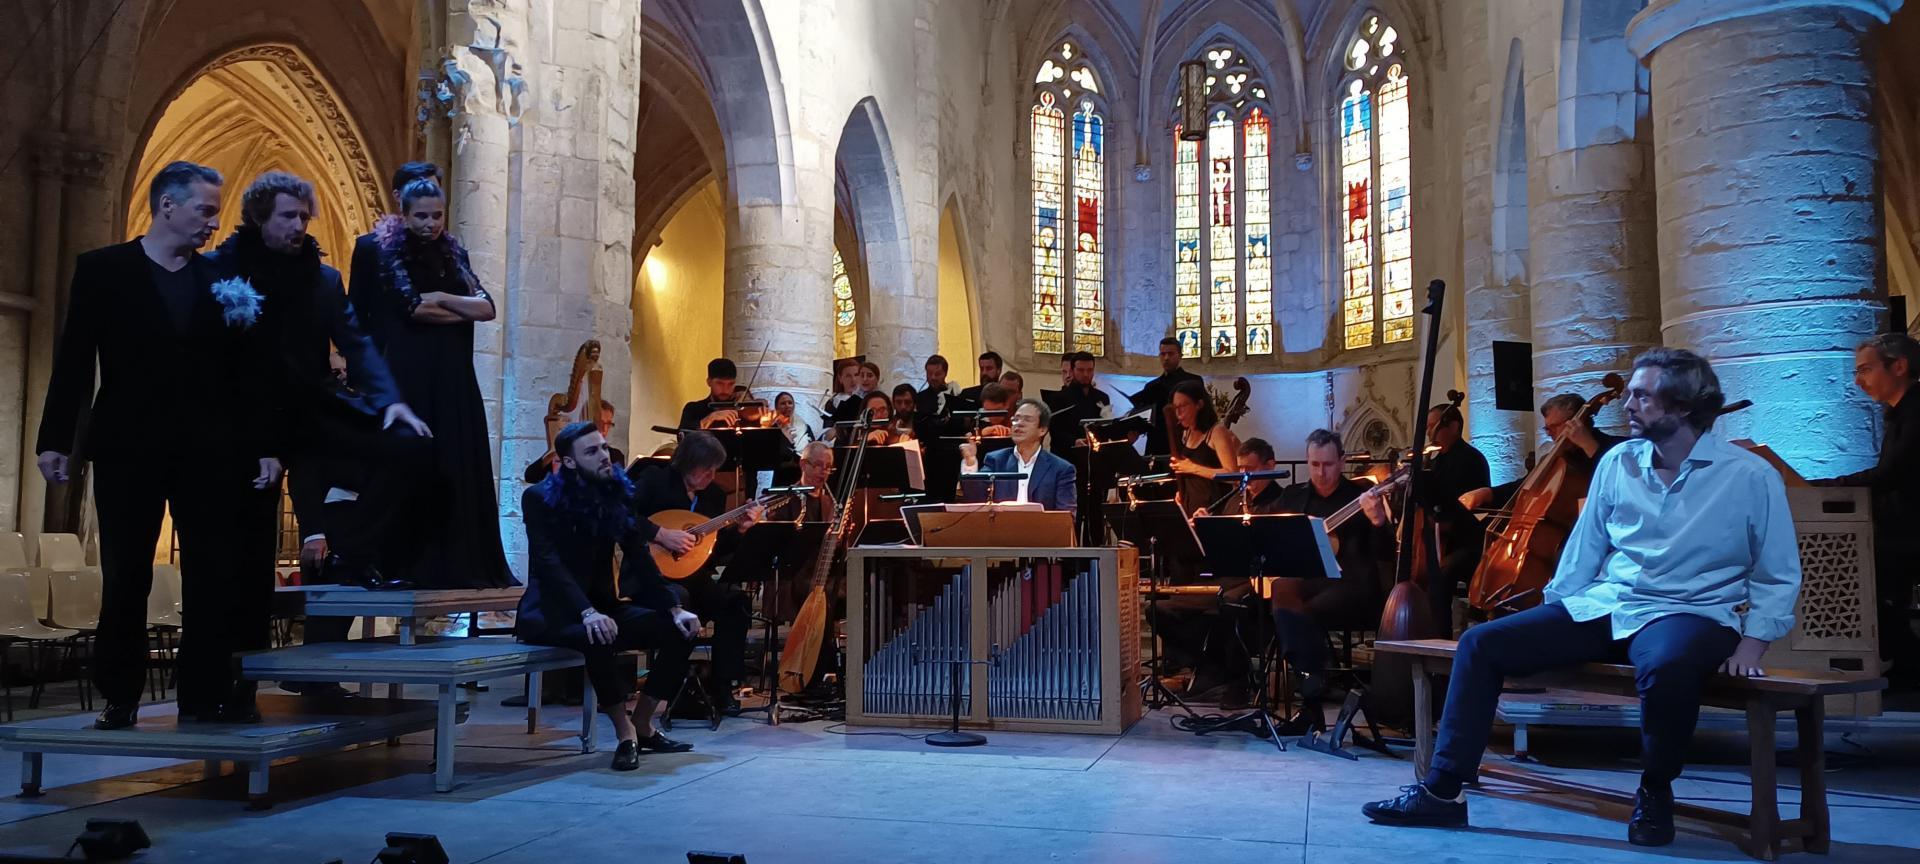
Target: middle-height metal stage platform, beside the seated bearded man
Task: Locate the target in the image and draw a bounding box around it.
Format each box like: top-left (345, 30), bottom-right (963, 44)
top-left (240, 637), bottom-right (595, 791)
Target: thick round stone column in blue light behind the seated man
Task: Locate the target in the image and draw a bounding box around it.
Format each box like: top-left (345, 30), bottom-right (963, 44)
top-left (1626, 0), bottom-right (1901, 476)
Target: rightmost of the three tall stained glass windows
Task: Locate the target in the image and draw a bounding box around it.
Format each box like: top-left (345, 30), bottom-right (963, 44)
top-left (1334, 15), bottom-right (1413, 348)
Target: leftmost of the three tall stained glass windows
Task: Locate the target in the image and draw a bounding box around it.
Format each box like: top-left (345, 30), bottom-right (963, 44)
top-left (1029, 42), bottom-right (1106, 355)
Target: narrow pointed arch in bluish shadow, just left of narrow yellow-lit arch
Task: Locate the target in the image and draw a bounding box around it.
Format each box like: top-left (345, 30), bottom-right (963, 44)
top-left (820, 96), bottom-right (918, 380)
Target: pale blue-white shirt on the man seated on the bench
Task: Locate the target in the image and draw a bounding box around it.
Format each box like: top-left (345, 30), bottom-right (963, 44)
top-left (1544, 430), bottom-right (1801, 641)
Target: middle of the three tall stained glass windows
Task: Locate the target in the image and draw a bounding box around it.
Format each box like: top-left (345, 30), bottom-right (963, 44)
top-left (1173, 44), bottom-right (1273, 357)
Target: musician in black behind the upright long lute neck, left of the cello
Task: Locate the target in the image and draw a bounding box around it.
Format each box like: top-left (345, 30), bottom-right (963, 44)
top-left (1423, 405), bottom-right (1492, 637)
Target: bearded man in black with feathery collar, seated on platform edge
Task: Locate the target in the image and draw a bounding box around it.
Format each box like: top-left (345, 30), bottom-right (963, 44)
top-left (513, 422), bottom-right (701, 772)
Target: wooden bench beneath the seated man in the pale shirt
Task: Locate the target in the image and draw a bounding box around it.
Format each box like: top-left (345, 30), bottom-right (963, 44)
top-left (1375, 639), bottom-right (1887, 860)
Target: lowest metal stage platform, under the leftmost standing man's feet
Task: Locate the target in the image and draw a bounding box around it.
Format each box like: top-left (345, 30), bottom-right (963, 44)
top-left (0, 695), bottom-right (445, 810)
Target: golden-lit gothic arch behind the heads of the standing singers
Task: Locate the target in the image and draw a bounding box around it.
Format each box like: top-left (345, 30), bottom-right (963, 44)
top-left (123, 42), bottom-right (382, 255)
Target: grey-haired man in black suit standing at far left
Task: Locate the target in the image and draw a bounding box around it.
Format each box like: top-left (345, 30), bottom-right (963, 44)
top-left (35, 161), bottom-right (280, 730)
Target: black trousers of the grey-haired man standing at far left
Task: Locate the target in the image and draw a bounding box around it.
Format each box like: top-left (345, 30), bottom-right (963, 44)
top-left (94, 457), bottom-right (276, 712)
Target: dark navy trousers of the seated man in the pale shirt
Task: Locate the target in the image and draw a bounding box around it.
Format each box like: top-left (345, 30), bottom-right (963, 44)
top-left (1430, 603), bottom-right (1740, 789)
